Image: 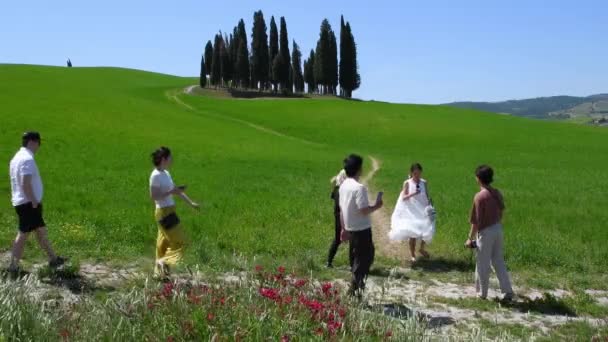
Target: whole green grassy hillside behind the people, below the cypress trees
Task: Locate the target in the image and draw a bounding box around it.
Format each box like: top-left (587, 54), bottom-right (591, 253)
top-left (0, 65), bottom-right (608, 286)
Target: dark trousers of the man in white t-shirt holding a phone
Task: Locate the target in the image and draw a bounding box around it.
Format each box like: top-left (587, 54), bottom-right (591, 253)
top-left (349, 227), bottom-right (375, 291)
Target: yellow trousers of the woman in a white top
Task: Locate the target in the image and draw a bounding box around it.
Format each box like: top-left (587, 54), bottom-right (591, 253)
top-left (154, 206), bottom-right (186, 275)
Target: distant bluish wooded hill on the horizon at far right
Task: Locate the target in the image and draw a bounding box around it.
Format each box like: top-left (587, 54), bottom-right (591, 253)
top-left (445, 94), bottom-right (608, 121)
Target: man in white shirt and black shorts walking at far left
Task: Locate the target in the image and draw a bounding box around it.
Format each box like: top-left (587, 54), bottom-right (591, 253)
top-left (9, 132), bottom-right (65, 274)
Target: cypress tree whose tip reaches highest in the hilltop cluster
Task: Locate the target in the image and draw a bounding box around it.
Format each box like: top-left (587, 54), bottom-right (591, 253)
top-left (251, 11), bottom-right (270, 90)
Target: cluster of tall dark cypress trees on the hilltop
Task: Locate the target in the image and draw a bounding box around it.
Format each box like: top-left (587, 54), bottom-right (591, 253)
top-left (200, 11), bottom-right (361, 98)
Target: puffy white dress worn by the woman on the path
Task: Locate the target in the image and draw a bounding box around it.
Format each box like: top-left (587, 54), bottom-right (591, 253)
top-left (388, 178), bottom-right (435, 243)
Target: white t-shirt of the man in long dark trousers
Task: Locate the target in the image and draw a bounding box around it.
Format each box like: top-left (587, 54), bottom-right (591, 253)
top-left (340, 178), bottom-right (372, 231)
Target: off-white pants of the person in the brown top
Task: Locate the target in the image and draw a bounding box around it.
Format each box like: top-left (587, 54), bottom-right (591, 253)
top-left (475, 223), bottom-right (513, 297)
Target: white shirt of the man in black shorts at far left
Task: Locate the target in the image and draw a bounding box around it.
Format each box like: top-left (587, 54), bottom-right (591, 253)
top-left (9, 147), bottom-right (43, 207)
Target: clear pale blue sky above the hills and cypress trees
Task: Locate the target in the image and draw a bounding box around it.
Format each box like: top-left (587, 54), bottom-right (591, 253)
top-left (0, 0), bottom-right (608, 103)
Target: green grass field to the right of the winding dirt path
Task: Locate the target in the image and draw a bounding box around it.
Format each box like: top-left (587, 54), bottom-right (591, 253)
top-left (184, 85), bottom-right (608, 280)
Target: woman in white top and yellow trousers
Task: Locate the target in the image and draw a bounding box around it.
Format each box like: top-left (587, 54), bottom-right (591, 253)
top-left (150, 146), bottom-right (199, 278)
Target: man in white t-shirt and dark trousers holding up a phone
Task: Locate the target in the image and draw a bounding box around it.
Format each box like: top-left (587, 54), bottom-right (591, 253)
top-left (340, 154), bottom-right (382, 295)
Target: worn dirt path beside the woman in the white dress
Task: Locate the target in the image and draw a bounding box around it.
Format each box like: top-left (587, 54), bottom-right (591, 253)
top-left (362, 156), bottom-right (407, 262)
